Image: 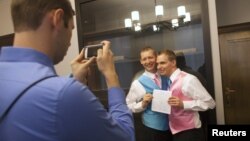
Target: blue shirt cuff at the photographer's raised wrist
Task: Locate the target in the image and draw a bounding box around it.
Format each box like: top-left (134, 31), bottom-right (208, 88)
top-left (108, 87), bottom-right (126, 106)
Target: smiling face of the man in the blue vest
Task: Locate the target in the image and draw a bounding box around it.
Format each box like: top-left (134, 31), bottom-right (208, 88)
top-left (140, 49), bottom-right (156, 73)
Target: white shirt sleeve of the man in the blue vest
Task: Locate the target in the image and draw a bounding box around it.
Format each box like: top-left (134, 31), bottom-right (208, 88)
top-left (126, 80), bottom-right (146, 113)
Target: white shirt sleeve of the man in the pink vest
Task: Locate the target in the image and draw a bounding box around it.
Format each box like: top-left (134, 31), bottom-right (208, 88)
top-left (182, 76), bottom-right (215, 111)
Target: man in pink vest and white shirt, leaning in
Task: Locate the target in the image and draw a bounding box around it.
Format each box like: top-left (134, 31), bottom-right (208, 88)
top-left (157, 49), bottom-right (215, 141)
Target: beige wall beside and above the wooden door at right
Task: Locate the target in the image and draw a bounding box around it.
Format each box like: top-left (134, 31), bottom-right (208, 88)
top-left (213, 0), bottom-right (250, 124)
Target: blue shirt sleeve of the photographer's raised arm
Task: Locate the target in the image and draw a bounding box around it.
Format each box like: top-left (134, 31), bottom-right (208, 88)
top-left (56, 81), bottom-right (135, 141)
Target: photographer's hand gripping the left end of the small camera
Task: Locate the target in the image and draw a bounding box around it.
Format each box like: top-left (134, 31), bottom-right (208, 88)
top-left (70, 50), bottom-right (95, 84)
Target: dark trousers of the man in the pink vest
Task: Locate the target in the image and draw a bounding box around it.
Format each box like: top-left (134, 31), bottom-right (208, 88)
top-left (173, 128), bottom-right (205, 141)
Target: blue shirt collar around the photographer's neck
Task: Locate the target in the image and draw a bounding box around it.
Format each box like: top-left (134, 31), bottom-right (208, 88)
top-left (0, 46), bottom-right (54, 69)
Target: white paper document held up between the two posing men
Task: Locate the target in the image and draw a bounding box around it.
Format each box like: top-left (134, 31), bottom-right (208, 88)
top-left (151, 90), bottom-right (172, 114)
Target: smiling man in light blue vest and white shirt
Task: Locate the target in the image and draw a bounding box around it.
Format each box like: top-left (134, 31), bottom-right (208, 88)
top-left (126, 47), bottom-right (171, 141)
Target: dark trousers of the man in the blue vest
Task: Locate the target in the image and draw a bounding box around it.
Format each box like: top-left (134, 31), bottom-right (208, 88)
top-left (145, 127), bottom-right (172, 141)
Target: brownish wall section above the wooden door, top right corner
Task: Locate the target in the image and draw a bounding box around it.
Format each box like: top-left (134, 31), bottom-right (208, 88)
top-left (216, 0), bottom-right (250, 27)
